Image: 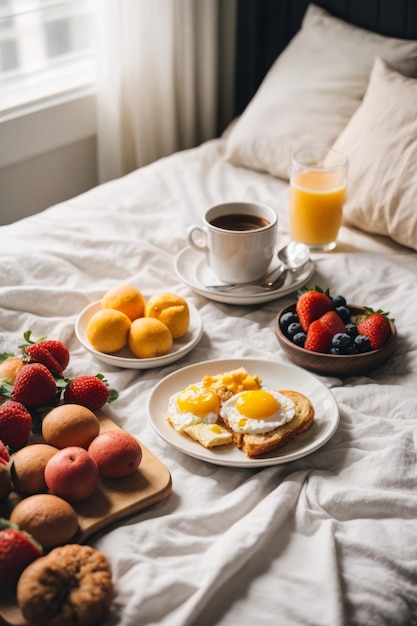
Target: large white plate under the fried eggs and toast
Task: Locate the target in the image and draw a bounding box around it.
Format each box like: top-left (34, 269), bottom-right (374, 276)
top-left (148, 358), bottom-right (339, 467)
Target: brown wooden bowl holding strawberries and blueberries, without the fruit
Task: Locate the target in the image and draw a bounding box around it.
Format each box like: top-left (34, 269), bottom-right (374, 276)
top-left (275, 303), bottom-right (397, 378)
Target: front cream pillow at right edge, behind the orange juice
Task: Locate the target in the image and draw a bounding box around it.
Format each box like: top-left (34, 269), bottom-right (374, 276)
top-left (334, 59), bottom-right (417, 250)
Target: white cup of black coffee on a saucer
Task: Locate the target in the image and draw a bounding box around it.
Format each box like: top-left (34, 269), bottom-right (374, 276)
top-left (187, 202), bottom-right (278, 283)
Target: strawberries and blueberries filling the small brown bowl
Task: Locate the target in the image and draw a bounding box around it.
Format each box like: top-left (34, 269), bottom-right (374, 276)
top-left (279, 286), bottom-right (391, 355)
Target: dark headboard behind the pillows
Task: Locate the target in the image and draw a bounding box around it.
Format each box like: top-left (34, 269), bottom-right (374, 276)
top-left (235, 0), bottom-right (417, 115)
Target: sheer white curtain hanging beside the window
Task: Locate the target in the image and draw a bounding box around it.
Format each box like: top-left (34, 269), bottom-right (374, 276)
top-left (97, 0), bottom-right (228, 182)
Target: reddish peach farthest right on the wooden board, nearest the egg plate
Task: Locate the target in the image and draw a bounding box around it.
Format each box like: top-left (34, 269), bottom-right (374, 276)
top-left (88, 429), bottom-right (142, 478)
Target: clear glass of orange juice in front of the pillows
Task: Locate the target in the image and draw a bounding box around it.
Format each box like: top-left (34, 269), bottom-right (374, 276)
top-left (290, 169), bottom-right (346, 249)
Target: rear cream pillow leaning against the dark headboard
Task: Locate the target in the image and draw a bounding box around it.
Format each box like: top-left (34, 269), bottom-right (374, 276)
top-left (225, 5), bottom-right (417, 179)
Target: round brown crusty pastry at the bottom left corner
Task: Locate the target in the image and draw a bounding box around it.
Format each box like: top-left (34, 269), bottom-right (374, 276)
top-left (16, 544), bottom-right (114, 626)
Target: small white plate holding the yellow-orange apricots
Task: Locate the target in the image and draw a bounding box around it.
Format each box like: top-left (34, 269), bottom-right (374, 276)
top-left (75, 300), bottom-right (203, 369)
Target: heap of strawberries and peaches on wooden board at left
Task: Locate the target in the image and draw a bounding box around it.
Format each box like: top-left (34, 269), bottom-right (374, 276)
top-left (0, 331), bottom-right (142, 591)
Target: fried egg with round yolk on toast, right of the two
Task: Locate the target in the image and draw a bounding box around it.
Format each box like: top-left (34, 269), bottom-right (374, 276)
top-left (220, 387), bottom-right (295, 435)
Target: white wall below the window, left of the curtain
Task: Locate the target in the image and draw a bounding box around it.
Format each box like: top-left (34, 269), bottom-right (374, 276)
top-left (0, 93), bottom-right (97, 224)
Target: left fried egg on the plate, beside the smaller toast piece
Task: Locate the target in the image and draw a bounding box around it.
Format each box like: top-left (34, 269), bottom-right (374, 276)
top-left (167, 383), bottom-right (220, 432)
